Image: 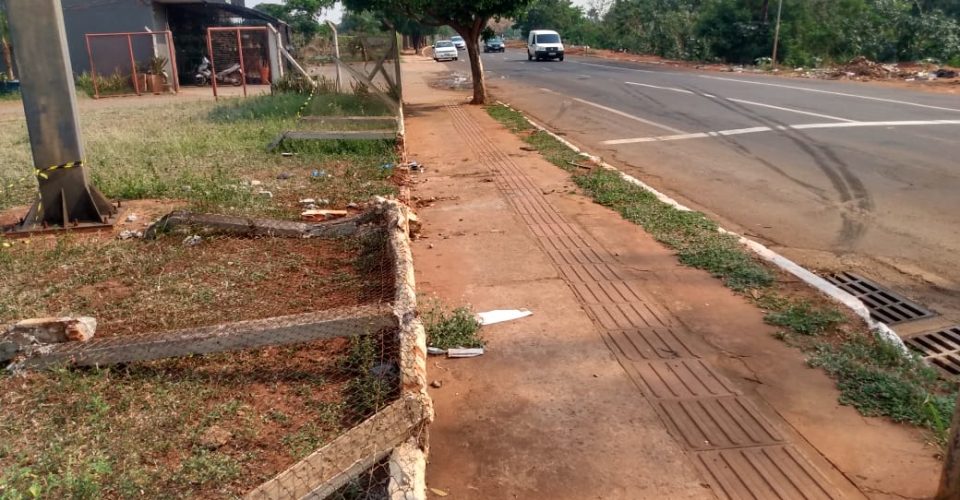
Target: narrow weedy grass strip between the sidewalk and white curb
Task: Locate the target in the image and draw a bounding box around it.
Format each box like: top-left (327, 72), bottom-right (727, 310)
top-left (487, 105), bottom-right (957, 444)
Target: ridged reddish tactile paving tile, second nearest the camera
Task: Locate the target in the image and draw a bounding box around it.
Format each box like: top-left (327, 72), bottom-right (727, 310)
top-left (659, 397), bottom-right (783, 450)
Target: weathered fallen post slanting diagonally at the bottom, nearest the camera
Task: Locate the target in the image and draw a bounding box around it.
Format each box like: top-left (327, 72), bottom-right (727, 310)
top-left (244, 395), bottom-right (426, 500)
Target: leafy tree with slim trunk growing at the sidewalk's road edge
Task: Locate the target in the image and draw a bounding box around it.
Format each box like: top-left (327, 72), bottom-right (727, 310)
top-left (344, 0), bottom-right (531, 104)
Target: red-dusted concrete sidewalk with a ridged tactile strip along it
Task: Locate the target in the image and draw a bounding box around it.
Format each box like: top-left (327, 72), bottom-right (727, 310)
top-left (404, 58), bottom-right (939, 499)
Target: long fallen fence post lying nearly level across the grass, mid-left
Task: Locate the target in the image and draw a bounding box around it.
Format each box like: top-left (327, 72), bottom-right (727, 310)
top-left (12, 306), bottom-right (396, 369)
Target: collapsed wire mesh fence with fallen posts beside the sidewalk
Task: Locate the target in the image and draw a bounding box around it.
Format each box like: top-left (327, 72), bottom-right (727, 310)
top-left (0, 201), bottom-right (431, 499)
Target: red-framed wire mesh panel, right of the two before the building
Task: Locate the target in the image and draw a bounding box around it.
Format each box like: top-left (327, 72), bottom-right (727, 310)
top-left (206, 26), bottom-right (272, 96)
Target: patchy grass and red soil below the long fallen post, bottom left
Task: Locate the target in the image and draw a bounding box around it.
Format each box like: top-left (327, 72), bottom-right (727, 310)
top-left (0, 339), bottom-right (355, 499)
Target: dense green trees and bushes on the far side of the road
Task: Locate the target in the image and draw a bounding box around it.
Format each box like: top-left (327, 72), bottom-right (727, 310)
top-left (515, 0), bottom-right (960, 67)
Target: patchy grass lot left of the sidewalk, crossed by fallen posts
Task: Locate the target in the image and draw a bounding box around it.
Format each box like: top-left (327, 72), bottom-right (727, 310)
top-left (0, 87), bottom-right (397, 499)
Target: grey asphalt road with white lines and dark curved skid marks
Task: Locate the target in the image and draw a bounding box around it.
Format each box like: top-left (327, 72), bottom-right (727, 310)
top-left (436, 50), bottom-right (960, 332)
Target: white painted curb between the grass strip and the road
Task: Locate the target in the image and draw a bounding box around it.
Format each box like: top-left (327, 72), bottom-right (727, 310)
top-left (497, 101), bottom-right (909, 353)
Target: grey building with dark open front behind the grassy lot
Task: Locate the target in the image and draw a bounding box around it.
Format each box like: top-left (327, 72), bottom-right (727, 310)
top-left (0, 0), bottom-right (289, 83)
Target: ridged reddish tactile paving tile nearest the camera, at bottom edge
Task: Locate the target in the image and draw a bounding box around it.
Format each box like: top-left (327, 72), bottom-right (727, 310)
top-left (694, 445), bottom-right (840, 500)
